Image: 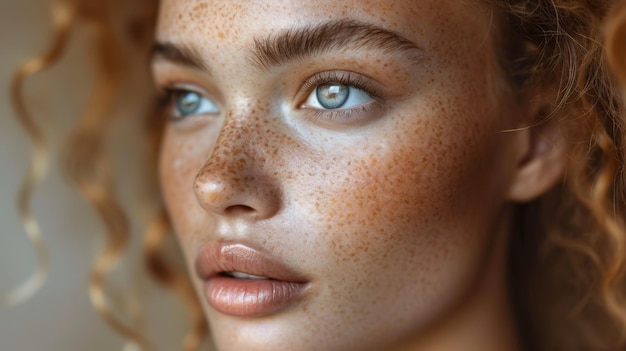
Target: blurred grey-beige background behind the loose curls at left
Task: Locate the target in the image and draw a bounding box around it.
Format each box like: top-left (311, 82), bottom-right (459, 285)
top-left (0, 0), bottom-right (188, 351)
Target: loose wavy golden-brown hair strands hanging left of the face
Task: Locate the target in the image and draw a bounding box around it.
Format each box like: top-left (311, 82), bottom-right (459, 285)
top-left (9, 0), bottom-right (207, 350)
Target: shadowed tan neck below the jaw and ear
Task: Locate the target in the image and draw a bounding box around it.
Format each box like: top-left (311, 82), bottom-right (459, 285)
top-left (400, 214), bottom-right (522, 351)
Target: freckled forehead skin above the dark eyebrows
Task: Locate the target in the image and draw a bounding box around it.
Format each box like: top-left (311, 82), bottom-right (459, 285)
top-left (157, 0), bottom-right (491, 52)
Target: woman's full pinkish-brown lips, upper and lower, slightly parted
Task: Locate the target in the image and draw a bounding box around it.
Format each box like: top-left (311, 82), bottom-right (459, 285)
top-left (195, 242), bottom-right (309, 317)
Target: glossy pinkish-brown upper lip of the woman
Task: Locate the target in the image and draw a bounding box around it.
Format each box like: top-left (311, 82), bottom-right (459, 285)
top-left (195, 242), bottom-right (307, 283)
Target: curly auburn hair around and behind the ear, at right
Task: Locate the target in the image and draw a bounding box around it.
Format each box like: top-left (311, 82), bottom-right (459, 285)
top-left (494, 0), bottom-right (626, 350)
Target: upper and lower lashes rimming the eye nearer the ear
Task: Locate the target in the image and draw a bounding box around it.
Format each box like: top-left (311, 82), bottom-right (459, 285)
top-left (298, 71), bottom-right (383, 124)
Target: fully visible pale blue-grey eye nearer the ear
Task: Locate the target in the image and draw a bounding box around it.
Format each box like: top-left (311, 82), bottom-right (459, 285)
top-left (304, 83), bottom-right (374, 110)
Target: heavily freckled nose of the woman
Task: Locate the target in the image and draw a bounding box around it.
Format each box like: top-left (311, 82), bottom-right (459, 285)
top-left (194, 119), bottom-right (281, 221)
